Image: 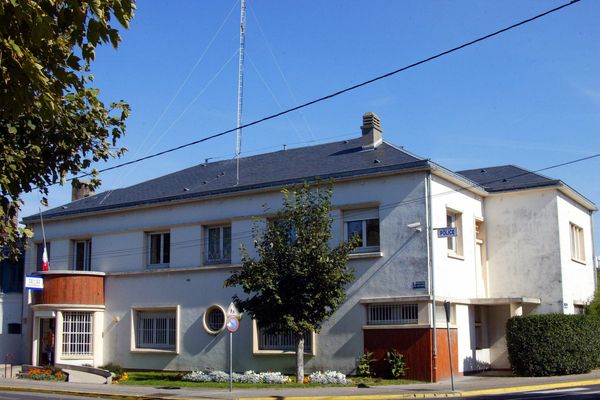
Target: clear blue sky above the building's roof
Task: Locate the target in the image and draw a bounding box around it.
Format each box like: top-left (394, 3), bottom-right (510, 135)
top-left (22, 0), bottom-right (600, 254)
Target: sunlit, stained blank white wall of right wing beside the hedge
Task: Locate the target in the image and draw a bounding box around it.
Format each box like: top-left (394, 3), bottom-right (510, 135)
top-left (485, 189), bottom-right (568, 313)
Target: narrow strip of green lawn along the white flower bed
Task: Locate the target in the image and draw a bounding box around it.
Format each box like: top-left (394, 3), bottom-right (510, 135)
top-left (119, 371), bottom-right (418, 389)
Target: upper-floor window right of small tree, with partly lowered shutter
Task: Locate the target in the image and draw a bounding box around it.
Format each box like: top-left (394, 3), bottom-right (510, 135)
top-left (344, 208), bottom-right (379, 252)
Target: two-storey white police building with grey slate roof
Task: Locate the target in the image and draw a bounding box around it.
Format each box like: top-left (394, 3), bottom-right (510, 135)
top-left (23, 113), bottom-right (596, 380)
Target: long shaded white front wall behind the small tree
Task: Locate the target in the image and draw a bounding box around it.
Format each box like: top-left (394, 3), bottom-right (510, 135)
top-left (21, 173), bottom-right (428, 372)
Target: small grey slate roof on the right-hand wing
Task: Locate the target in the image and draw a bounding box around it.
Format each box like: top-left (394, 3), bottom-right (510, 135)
top-left (457, 165), bottom-right (561, 192)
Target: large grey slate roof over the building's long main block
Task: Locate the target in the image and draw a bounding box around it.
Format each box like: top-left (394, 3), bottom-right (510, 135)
top-left (24, 138), bottom-right (428, 222)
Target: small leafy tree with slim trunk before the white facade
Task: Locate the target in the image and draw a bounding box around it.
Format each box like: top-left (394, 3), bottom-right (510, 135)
top-left (225, 183), bottom-right (359, 383)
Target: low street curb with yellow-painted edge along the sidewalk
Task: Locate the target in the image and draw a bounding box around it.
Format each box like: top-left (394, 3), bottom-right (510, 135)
top-left (0, 379), bottom-right (600, 400)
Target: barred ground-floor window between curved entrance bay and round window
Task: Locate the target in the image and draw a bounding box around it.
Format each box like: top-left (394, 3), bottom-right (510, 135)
top-left (135, 310), bottom-right (177, 350)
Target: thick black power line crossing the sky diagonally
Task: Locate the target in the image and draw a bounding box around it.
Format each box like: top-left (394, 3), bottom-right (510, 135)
top-left (57, 0), bottom-right (581, 186)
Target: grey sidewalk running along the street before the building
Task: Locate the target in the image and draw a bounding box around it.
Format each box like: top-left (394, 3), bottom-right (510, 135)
top-left (0, 370), bottom-right (600, 400)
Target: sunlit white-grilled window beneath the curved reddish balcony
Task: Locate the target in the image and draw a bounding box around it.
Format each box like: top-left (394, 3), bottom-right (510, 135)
top-left (62, 311), bottom-right (92, 356)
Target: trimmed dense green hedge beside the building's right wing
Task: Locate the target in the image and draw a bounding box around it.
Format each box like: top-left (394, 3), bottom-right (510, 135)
top-left (506, 314), bottom-right (600, 376)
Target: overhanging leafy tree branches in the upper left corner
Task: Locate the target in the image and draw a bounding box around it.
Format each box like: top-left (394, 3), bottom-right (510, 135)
top-left (0, 0), bottom-right (135, 254)
